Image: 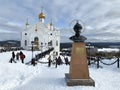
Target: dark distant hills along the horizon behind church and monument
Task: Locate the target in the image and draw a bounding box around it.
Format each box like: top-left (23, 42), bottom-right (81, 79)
top-left (0, 40), bottom-right (120, 48)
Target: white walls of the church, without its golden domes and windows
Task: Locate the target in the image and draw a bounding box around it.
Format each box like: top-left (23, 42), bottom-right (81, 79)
top-left (21, 10), bottom-right (60, 53)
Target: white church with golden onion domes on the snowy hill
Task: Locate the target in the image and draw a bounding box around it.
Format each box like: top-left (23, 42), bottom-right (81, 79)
top-left (21, 10), bottom-right (60, 55)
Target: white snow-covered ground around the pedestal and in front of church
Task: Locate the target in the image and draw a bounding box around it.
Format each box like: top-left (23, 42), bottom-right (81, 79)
top-left (0, 51), bottom-right (120, 90)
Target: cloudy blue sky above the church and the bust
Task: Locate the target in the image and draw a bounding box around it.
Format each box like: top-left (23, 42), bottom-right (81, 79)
top-left (0, 0), bottom-right (120, 42)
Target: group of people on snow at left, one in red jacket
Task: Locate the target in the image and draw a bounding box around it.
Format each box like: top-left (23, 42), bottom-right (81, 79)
top-left (9, 51), bottom-right (25, 63)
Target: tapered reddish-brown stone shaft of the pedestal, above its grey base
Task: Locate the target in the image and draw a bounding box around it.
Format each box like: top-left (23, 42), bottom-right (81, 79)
top-left (70, 43), bottom-right (89, 79)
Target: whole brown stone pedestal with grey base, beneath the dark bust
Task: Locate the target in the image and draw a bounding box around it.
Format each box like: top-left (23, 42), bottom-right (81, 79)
top-left (65, 42), bottom-right (95, 86)
